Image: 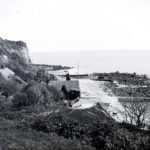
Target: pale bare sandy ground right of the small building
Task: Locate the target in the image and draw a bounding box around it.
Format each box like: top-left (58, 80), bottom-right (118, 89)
top-left (73, 79), bottom-right (123, 121)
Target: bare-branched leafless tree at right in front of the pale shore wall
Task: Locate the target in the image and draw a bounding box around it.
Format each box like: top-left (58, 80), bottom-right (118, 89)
top-left (121, 98), bottom-right (150, 128)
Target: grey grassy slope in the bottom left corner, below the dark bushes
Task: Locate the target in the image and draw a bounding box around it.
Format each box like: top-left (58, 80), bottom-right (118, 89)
top-left (0, 105), bottom-right (94, 150)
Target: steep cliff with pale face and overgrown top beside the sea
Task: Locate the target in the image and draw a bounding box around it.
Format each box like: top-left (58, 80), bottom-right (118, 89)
top-left (0, 38), bottom-right (31, 68)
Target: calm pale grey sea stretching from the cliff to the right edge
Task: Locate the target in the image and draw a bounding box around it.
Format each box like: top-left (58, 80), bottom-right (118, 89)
top-left (30, 50), bottom-right (150, 75)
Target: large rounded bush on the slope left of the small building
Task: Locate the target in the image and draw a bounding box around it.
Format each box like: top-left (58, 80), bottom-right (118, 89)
top-left (12, 82), bottom-right (54, 107)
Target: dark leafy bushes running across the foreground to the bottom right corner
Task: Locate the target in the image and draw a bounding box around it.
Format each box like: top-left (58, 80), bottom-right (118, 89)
top-left (31, 113), bottom-right (150, 150)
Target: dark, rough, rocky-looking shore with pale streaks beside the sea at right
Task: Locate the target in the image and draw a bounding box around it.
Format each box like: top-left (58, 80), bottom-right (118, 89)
top-left (95, 72), bottom-right (150, 97)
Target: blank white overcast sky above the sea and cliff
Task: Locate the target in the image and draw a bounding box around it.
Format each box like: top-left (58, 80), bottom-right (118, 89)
top-left (0, 0), bottom-right (150, 52)
